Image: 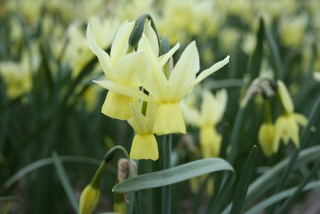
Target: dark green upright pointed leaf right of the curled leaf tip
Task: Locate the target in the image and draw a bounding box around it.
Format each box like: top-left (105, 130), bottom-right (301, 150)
top-left (230, 146), bottom-right (257, 214)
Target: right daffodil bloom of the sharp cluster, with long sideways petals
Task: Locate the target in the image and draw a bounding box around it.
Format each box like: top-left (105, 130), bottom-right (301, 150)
top-left (92, 20), bottom-right (229, 135)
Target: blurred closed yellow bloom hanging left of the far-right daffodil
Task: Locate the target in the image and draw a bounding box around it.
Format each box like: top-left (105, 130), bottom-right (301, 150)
top-left (258, 123), bottom-right (279, 157)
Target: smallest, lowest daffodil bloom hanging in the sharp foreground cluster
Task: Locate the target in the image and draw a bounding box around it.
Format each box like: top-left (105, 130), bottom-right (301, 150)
top-left (128, 103), bottom-right (159, 160)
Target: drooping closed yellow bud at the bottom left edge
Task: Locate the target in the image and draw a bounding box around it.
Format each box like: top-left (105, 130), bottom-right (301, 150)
top-left (79, 184), bottom-right (100, 214)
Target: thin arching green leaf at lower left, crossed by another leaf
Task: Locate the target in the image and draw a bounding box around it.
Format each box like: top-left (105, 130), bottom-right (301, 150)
top-left (4, 156), bottom-right (101, 188)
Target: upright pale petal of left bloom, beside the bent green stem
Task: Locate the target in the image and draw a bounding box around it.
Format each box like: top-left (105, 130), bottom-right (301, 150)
top-left (110, 22), bottom-right (134, 65)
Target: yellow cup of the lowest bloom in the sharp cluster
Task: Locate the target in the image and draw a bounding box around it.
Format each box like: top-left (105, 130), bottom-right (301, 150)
top-left (130, 134), bottom-right (159, 160)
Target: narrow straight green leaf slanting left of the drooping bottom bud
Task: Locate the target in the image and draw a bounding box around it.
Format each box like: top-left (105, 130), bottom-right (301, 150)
top-left (52, 152), bottom-right (79, 213)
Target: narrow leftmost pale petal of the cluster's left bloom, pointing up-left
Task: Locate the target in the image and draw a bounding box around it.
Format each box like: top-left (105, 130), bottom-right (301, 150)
top-left (87, 24), bottom-right (113, 80)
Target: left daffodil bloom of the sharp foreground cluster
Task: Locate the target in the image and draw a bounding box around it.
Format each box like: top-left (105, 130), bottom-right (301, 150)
top-left (87, 21), bottom-right (150, 120)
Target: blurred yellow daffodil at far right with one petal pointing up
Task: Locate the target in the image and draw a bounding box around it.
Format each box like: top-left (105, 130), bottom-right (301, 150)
top-left (273, 80), bottom-right (307, 152)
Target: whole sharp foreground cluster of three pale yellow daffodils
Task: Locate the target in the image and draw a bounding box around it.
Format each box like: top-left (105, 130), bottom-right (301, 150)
top-left (87, 21), bottom-right (229, 160)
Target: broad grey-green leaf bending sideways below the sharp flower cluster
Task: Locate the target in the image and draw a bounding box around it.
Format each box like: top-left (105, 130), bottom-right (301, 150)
top-left (113, 158), bottom-right (234, 193)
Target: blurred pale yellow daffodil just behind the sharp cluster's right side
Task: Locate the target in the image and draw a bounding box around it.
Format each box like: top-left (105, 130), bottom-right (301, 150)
top-left (181, 90), bottom-right (227, 158)
